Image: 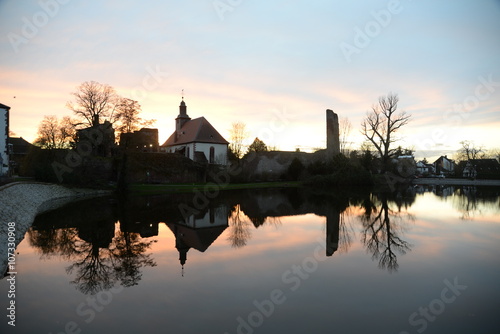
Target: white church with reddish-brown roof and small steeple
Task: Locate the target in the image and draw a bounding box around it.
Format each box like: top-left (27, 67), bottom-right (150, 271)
top-left (160, 98), bottom-right (229, 165)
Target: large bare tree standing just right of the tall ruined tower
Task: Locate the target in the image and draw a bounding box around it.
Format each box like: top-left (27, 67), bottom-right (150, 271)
top-left (361, 93), bottom-right (411, 170)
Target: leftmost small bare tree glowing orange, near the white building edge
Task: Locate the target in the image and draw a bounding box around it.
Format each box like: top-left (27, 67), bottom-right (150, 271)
top-left (35, 115), bottom-right (75, 149)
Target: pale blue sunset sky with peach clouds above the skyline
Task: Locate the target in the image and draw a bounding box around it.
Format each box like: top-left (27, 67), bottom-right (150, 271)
top-left (0, 0), bottom-right (500, 157)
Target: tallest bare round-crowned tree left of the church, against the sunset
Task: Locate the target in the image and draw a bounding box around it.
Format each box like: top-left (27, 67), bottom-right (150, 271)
top-left (66, 81), bottom-right (121, 126)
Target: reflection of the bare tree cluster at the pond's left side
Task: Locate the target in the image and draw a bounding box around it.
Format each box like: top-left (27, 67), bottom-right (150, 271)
top-left (28, 222), bottom-right (156, 294)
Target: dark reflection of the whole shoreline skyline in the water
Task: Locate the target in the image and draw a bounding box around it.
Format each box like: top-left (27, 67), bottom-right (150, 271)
top-left (28, 187), bottom-right (500, 294)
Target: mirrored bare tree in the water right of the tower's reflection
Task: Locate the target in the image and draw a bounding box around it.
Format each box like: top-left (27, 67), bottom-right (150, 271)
top-left (361, 194), bottom-right (414, 272)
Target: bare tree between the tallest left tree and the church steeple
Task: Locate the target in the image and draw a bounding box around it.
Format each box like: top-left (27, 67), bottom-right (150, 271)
top-left (115, 98), bottom-right (156, 137)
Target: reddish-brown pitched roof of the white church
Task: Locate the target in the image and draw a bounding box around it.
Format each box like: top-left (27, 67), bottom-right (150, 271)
top-left (161, 117), bottom-right (229, 147)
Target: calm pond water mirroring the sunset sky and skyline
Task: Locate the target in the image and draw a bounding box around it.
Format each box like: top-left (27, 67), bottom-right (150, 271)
top-left (0, 188), bottom-right (500, 334)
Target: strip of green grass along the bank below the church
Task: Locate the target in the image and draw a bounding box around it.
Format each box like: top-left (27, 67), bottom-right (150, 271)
top-left (128, 181), bottom-right (301, 195)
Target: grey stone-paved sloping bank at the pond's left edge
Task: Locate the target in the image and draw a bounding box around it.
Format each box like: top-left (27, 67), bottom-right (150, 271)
top-left (0, 182), bottom-right (110, 277)
